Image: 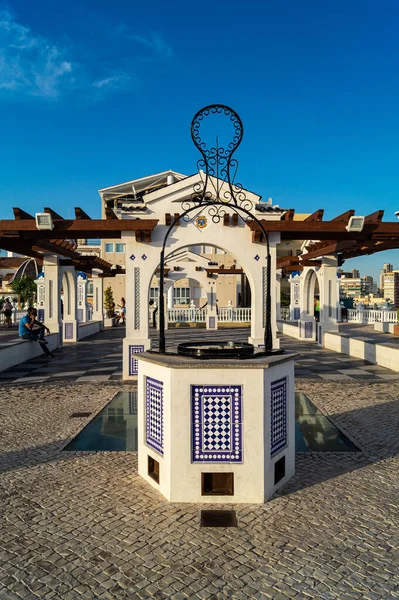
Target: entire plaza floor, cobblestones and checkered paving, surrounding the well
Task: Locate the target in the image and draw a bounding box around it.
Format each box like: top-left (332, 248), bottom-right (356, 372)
top-left (0, 327), bottom-right (399, 600)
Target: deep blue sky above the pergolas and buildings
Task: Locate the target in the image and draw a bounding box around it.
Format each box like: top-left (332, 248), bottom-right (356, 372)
top-left (0, 0), bottom-right (399, 276)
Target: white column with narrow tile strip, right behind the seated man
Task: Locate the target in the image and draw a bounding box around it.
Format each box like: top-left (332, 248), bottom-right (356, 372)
top-left (43, 254), bottom-right (62, 343)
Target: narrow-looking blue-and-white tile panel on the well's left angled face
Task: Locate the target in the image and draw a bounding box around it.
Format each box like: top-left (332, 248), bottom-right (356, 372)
top-left (145, 377), bottom-right (163, 456)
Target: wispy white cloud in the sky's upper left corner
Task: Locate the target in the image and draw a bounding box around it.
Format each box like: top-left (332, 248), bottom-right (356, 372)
top-left (0, 8), bottom-right (74, 98)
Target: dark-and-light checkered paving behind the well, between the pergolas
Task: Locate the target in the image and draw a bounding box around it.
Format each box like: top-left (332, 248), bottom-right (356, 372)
top-left (0, 327), bottom-right (399, 384)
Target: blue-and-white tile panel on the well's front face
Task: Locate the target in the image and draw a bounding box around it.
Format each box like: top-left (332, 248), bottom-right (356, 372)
top-left (191, 384), bottom-right (243, 463)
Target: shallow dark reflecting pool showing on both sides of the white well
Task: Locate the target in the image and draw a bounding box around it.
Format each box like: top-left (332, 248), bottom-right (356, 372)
top-left (64, 392), bottom-right (359, 452)
